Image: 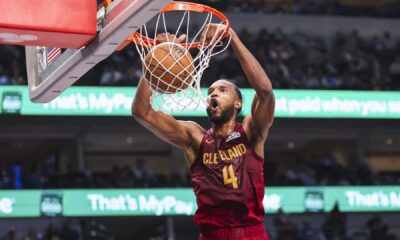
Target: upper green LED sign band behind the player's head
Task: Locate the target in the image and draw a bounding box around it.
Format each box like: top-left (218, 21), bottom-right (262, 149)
top-left (0, 86), bottom-right (400, 119)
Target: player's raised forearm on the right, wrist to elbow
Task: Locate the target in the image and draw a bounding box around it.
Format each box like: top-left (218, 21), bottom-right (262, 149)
top-left (231, 30), bottom-right (272, 96)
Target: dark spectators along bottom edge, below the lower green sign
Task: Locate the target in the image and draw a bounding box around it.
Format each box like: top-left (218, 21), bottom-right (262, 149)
top-left (0, 205), bottom-right (398, 240)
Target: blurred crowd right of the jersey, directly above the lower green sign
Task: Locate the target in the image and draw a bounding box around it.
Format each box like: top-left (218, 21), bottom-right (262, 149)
top-left (264, 156), bottom-right (400, 186)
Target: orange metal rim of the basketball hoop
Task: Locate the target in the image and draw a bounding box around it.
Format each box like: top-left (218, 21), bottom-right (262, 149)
top-left (133, 2), bottom-right (230, 48)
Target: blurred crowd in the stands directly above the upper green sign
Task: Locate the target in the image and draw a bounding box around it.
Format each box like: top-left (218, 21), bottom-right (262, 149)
top-left (0, 29), bottom-right (400, 90)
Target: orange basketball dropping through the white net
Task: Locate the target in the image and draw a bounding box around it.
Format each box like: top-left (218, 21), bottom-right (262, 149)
top-left (144, 42), bottom-right (194, 94)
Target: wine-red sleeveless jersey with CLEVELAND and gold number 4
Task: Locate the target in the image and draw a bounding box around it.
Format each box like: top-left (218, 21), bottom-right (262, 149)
top-left (191, 123), bottom-right (264, 231)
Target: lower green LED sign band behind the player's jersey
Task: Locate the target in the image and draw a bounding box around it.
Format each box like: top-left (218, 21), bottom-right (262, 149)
top-left (0, 186), bottom-right (400, 218)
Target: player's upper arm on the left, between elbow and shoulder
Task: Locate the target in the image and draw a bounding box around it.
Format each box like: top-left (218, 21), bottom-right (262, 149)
top-left (136, 110), bottom-right (195, 148)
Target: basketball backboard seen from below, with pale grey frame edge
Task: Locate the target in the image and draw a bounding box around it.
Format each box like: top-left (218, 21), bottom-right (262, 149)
top-left (25, 0), bottom-right (171, 103)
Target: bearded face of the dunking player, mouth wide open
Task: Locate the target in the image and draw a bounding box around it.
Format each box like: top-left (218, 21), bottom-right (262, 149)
top-left (207, 80), bottom-right (238, 125)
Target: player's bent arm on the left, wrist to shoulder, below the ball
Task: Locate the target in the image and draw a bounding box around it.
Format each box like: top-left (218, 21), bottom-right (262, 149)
top-left (132, 78), bottom-right (204, 153)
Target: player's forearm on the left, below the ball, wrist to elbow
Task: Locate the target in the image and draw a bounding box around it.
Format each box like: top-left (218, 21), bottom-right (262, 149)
top-left (131, 78), bottom-right (153, 118)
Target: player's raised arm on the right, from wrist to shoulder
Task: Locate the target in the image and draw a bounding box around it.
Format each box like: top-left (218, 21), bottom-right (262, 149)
top-left (230, 30), bottom-right (275, 140)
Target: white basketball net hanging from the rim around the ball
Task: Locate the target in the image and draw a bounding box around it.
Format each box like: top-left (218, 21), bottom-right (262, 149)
top-left (133, 2), bottom-right (231, 112)
